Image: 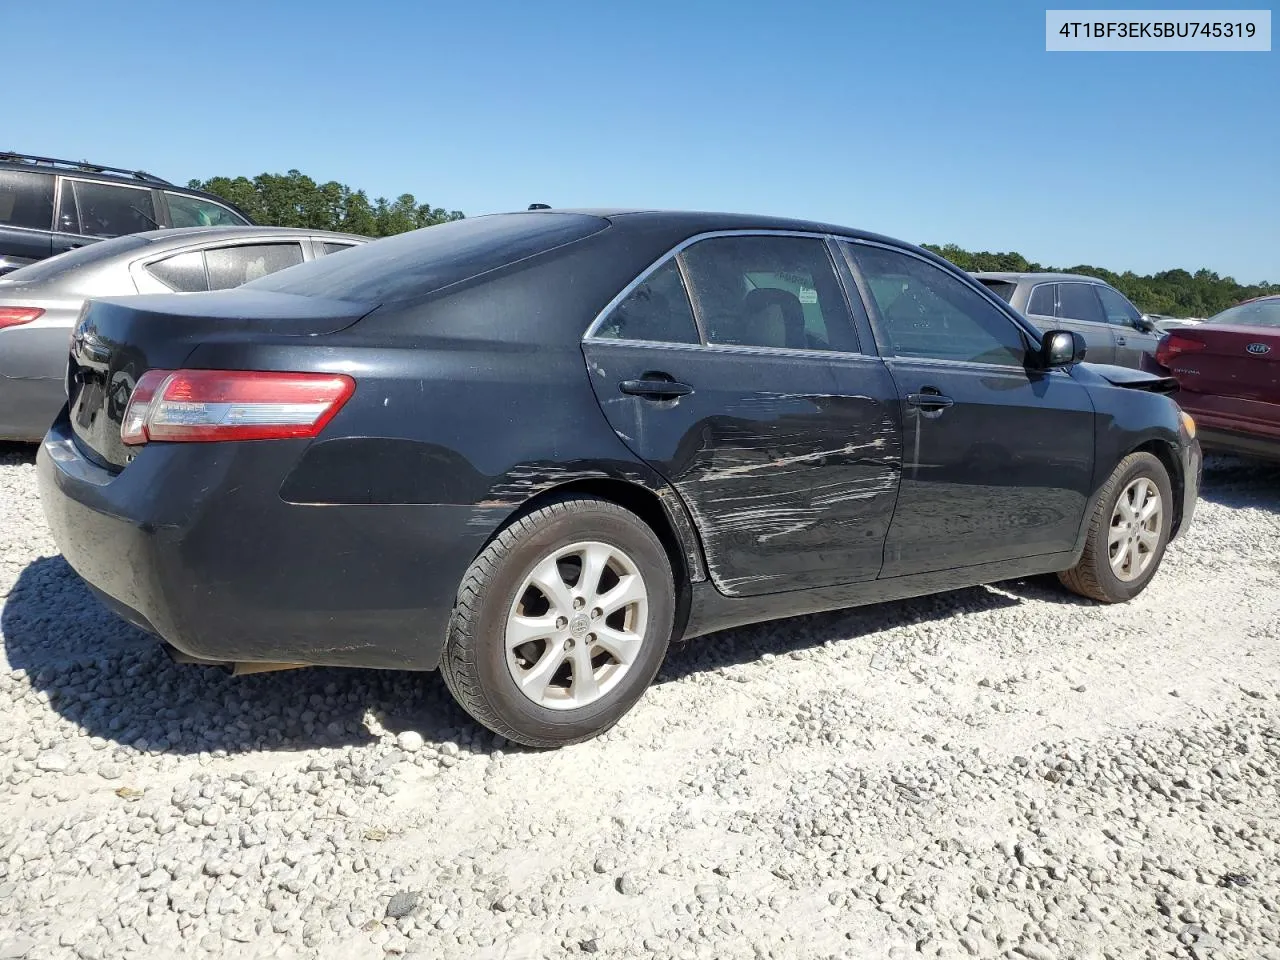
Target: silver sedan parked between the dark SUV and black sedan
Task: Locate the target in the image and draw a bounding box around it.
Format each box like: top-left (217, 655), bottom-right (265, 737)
top-left (0, 227), bottom-right (369, 442)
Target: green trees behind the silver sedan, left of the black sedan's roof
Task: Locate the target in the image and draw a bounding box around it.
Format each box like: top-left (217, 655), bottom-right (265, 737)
top-left (187, 170), bottom-right (462, 237)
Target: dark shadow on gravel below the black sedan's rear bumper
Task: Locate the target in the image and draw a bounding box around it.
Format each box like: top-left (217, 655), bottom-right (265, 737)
top-left (0, 557), bottom-right (494, 754)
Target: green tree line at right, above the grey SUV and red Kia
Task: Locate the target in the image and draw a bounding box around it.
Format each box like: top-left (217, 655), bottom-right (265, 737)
top-left (923, 243), bottom-right (1280, 317)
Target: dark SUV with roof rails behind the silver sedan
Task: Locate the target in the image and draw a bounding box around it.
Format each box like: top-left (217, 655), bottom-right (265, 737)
top-left (0, 154), bottom-right (253, 274)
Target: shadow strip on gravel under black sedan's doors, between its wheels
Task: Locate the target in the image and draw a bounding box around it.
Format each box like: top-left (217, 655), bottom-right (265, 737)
top-left (655, 581), bottom-right (1024, 684)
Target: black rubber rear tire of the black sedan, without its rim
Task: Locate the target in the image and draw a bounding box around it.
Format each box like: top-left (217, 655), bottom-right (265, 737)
top-left (440, 497), bottom-right (676, 748)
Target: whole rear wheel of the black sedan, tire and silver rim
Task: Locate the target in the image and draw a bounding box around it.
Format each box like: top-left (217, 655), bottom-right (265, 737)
top-left (440, 497), bottom-right (676, 748)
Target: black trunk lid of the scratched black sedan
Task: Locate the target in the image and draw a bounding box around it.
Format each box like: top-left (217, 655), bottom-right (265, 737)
top-left (67, 291), bottom-right (372, 467)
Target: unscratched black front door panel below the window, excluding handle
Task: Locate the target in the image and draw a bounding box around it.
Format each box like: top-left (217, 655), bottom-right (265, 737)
top-left (882, 360), bottom-right (1093, 577)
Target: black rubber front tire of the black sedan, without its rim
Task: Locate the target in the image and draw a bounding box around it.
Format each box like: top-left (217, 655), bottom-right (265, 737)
top-left (1057, 453), bottom-right (1174, 603)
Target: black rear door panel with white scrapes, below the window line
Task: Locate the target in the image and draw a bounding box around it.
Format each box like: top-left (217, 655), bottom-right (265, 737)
top-left (584, 340), bottom-right (900, 595)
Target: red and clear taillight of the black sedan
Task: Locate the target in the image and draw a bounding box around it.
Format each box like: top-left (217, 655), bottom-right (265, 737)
top-left (120, 370), bottom-right (356, 445)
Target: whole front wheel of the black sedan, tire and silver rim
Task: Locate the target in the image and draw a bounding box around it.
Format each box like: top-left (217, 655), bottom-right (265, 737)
top-left (1057, 453), bottom-right (1174, 603)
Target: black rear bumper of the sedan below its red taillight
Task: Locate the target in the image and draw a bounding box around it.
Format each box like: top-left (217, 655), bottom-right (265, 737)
top-left (37, 415), bottom-right (497, 669)
